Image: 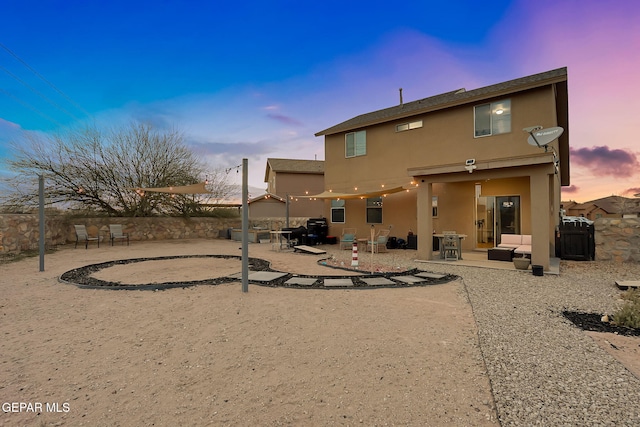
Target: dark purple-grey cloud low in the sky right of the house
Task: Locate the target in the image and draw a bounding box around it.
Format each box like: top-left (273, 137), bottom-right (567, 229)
top-left (571, 145), bottom-right (640, 178)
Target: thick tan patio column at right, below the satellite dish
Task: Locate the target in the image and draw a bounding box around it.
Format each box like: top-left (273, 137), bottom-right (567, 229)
top-left (529, 171), bottom-right (553, 270)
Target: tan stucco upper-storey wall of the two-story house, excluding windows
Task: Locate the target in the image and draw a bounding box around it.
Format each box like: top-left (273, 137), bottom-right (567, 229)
top-left (325, 88), bottom-right (557, 191)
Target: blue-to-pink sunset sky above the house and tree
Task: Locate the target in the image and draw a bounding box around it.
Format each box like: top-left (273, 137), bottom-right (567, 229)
top-left (0, 0), bottom-right (640, 201)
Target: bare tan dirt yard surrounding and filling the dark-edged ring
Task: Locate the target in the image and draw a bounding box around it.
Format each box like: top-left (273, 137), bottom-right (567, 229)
top-left (0, 240), bottom-right (498, 426)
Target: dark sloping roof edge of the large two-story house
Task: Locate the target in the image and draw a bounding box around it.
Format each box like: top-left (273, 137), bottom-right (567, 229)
top-left (315, 67), bottom-right (567, 136)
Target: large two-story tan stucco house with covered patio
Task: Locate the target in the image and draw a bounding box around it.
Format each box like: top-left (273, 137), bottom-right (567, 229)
top-left (316, 68), bottom-right (569, 269)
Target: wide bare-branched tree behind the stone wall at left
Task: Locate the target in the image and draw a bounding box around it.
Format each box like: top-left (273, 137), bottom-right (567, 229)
top-left (3, 122), bottom-right (228, 216)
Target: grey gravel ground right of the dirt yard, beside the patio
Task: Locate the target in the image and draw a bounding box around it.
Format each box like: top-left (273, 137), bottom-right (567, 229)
top-left (324, 251), bottom-right (640, 426)
